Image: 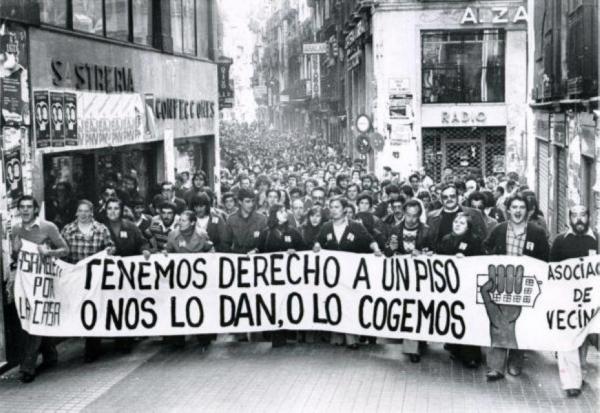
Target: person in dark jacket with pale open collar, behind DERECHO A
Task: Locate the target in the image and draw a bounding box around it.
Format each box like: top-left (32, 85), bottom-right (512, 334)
top-left (313, 197), bottom-right (382, 349)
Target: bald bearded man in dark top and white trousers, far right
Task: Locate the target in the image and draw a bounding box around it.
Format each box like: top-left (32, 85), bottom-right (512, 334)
top-left (550, 205), bottom-right (598, 397)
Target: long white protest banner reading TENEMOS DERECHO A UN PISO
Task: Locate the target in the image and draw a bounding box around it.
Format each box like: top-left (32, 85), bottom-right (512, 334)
top-left (15, 241), bottom-right (600, 350)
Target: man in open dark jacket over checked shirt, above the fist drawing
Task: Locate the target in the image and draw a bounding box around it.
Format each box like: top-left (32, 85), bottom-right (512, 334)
top-left (483, 195), bottom-right (550, 381)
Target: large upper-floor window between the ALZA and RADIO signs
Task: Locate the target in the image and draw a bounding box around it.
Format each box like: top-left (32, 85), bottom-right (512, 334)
top-left (422, 30), bottom-right (505, 103)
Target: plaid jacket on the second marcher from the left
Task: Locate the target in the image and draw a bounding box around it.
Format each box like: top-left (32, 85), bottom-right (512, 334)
top-left (62, 220), bottom-right (114, 264)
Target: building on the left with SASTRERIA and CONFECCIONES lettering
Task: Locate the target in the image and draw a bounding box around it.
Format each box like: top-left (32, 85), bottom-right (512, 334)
top-left (0, 0), bottom-right (219, 366)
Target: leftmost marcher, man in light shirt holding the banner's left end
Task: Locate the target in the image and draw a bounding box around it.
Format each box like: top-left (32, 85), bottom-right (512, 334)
top-left (7, 195), bottom-right (69, 383)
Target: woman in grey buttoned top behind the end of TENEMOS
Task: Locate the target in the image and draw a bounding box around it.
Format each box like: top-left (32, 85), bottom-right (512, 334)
top-left (163, 210), bottom-right (216, 349)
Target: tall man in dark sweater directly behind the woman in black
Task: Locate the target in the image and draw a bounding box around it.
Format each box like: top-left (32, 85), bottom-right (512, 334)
top-left (427, 184), bottom-right (487, 251)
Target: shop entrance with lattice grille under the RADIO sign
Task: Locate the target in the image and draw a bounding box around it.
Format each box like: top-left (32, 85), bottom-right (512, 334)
top-left (423, 127), bottom-right (506, 182)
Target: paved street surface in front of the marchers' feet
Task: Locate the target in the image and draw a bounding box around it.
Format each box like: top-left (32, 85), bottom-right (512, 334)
top-left (0, 338), bottom-right (600, 413)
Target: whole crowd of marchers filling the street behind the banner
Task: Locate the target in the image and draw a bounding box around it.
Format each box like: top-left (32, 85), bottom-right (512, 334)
top-left (3, 124), bottom-right (598, 397)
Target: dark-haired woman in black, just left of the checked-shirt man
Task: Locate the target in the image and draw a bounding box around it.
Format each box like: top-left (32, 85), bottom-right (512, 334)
top-left (438, 212), bottom-right (483, 369)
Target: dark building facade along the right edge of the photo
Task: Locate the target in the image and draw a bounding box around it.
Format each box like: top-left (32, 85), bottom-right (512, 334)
top-left (529, 0), bottom-right (600, 234)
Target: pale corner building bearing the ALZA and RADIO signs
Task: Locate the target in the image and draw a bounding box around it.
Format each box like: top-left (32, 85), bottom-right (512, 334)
top-left (258, 0), bottom-right (529, 179)
